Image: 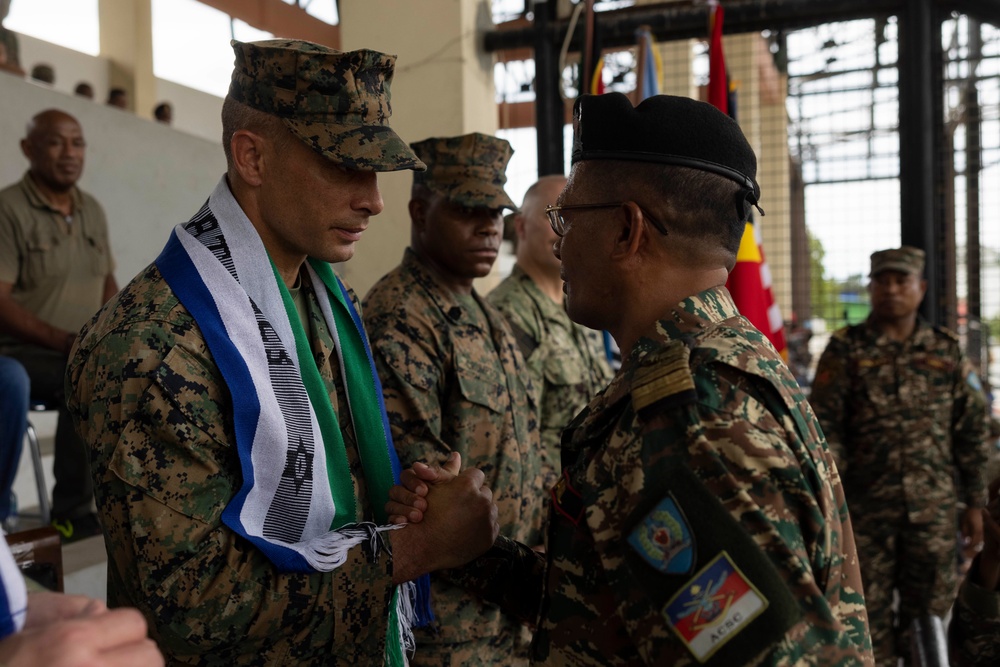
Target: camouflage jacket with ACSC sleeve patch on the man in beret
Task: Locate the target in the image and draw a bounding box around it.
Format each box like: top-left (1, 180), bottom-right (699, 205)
top-left (450, 287), bottom-right (872, 667)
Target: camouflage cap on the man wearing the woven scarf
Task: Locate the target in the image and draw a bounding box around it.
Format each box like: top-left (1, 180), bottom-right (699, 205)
top-left (229, 39), bottom-right (424, 171)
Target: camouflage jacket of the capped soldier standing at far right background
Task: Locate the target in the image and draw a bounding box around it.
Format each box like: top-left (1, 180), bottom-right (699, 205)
top-left (810, 319), bottom-right (987, 523)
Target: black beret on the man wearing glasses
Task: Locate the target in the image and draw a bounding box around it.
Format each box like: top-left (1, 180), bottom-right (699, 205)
top-left (572, 93), bottom-right (763, 214)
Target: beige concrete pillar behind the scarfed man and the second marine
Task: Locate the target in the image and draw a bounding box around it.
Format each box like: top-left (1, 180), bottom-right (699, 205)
top-left (336, 0), bottom-right (497, 295)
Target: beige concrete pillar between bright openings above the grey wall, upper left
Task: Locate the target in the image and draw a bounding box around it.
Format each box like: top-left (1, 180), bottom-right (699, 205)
top-left (98, 0), bottom-right (157, 119)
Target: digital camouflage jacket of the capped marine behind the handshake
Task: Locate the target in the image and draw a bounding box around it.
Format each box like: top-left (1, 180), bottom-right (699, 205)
top-left (364, 249), bottom-right (544, 644)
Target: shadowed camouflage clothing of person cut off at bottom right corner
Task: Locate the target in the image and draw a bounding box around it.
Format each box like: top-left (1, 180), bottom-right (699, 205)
top-left (948, 562), bottom-right (1000, 667)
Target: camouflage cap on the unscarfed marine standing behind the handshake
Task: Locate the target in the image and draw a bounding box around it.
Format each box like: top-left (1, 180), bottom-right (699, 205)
top-left (410, 132), bottom-right (517, 211)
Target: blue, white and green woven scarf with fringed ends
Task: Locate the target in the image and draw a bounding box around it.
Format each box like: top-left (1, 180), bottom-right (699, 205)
top-left (156, 178), bottom-right (430, 665)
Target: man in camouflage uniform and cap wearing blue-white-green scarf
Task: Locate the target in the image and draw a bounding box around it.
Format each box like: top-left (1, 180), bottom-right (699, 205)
top-left (67, 40), bottom-right (496, 667)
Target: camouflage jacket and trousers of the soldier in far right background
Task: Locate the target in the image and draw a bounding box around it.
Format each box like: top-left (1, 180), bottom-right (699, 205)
top-left (810, 318), bottom-right (987, 664)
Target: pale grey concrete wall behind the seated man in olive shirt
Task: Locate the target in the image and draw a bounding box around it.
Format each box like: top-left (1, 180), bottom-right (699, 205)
top-left (0, 73), bottom-right (225, 285)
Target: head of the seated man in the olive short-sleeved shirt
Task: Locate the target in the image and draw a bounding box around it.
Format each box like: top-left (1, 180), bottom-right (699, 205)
top-left (21, 109), bottom-right (87, 193)
